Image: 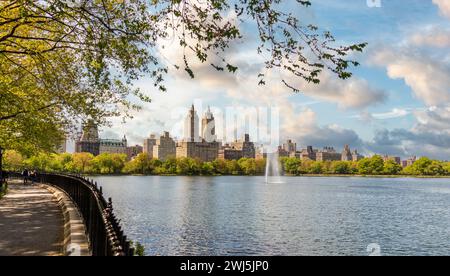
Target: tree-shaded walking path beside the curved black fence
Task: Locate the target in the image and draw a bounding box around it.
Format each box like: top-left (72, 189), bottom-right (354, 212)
top-left (0, 182), bottom-right (64, 256)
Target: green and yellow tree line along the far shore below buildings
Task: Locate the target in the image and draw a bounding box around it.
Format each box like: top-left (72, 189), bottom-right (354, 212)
top-left (4, 150), bottom-right (450, 176)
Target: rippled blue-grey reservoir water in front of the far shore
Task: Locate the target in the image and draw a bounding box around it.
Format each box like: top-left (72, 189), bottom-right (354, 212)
top-left (95, 176), bottom-right (450, 256)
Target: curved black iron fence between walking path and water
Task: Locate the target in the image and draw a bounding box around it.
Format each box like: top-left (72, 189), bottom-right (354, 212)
top-left (39, 174), bottom-right (134, 256)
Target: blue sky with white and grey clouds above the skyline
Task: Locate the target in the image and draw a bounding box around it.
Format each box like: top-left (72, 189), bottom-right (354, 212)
top-left (86, 0), bottom-right (450, 160)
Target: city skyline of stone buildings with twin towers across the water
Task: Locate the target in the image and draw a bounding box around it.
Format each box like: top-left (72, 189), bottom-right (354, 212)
top-left (75, 104), bottom-right (417, 164)
